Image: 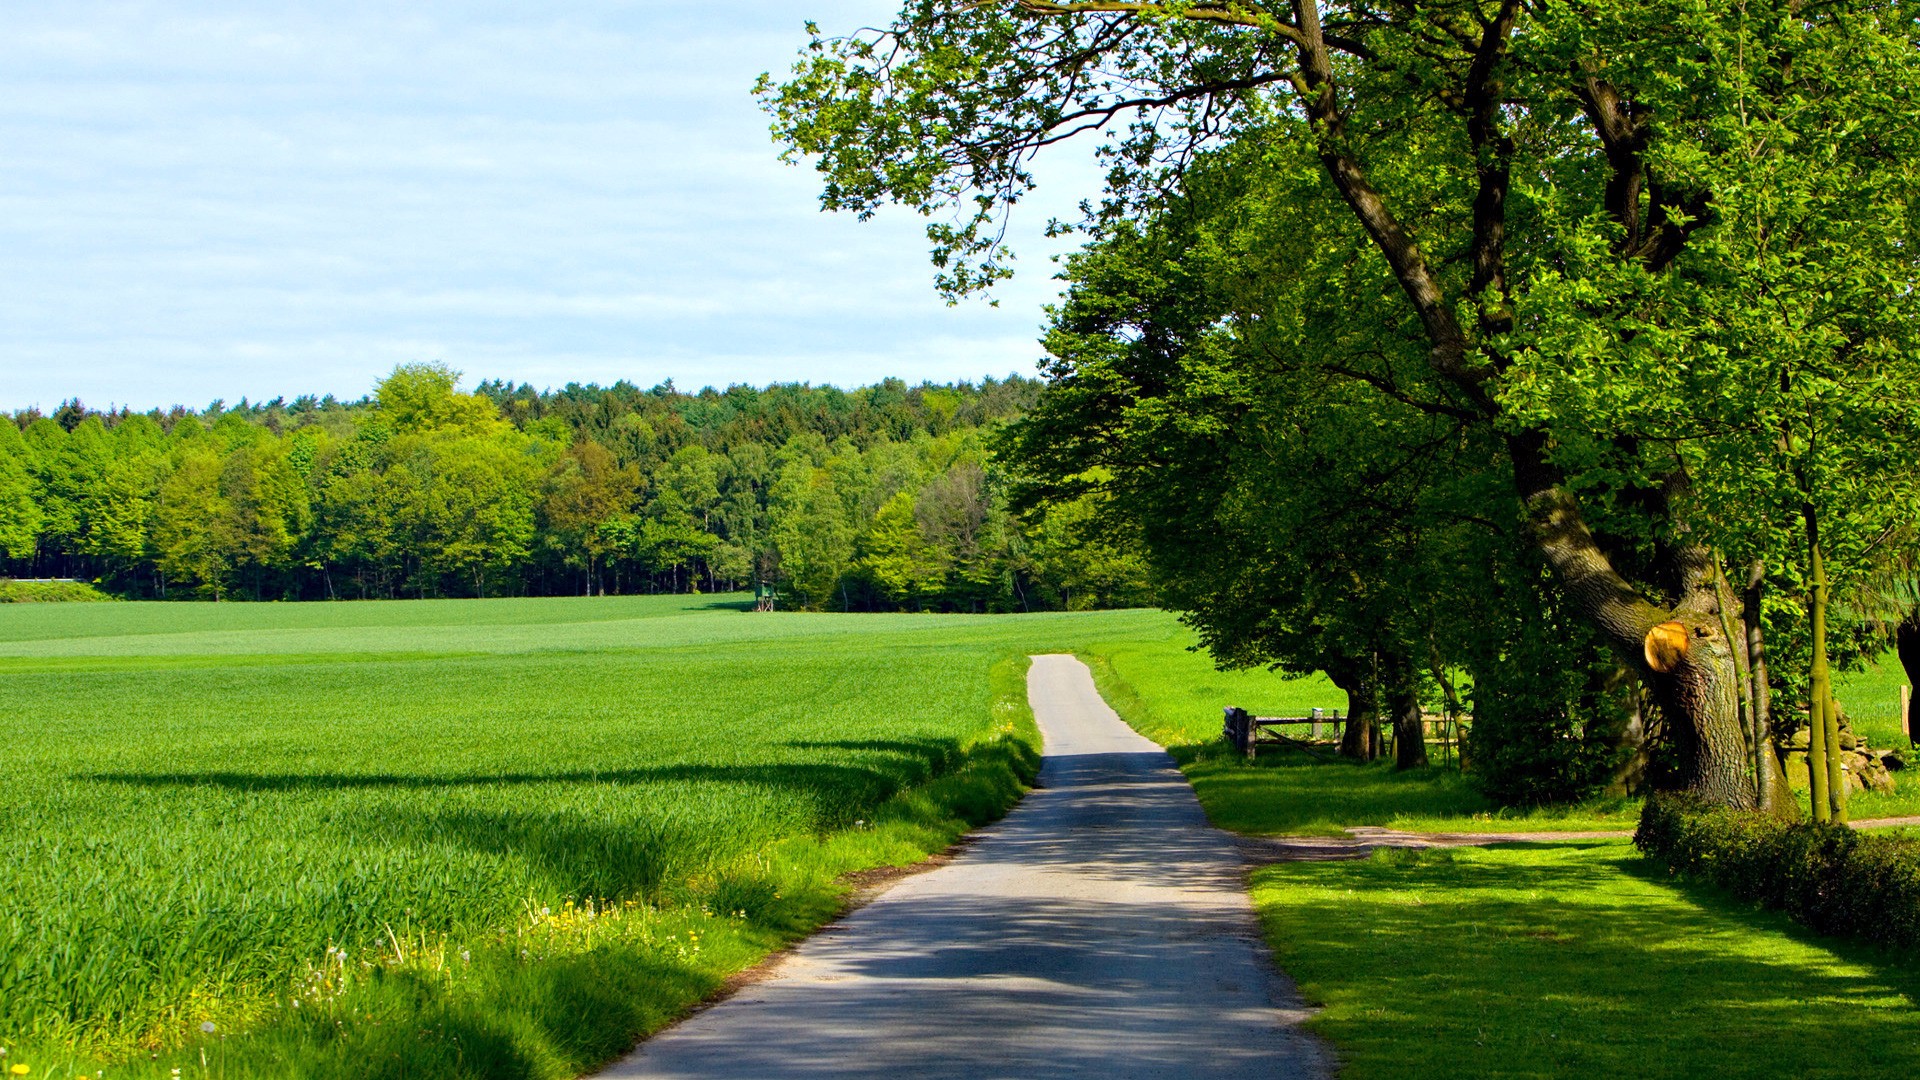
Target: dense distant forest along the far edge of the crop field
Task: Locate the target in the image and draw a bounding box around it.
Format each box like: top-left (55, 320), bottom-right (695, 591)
top-left (0, 365), bottom-right (1150, 611)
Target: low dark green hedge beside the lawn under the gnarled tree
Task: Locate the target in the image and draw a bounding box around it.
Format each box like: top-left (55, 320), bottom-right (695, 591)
top-left (1634, 796), bottom-right (1920, 949)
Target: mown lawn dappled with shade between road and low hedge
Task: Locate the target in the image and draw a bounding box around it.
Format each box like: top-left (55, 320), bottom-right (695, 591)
top-left (1256, 842), bottom-right (1920, 1080)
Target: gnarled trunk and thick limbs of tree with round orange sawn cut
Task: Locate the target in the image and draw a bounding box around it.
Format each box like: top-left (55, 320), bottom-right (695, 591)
top-left (1292, 0), bottom-right (1761, 809)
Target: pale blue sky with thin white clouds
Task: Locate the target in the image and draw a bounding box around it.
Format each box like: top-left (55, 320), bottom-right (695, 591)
top-left (0, 0), bottom-right (1096, 409)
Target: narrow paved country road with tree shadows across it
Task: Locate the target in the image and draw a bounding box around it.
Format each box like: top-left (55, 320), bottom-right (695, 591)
top-left (605, 655), bottom-right (1329, 1080)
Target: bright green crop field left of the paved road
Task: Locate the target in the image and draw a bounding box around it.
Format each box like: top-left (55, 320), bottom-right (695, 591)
top-left (0, 598), bottom-right (1288, 1076)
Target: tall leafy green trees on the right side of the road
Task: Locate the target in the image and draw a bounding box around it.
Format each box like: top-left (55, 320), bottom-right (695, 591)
top-left (760, 0), bottom-right (1920, 817)
